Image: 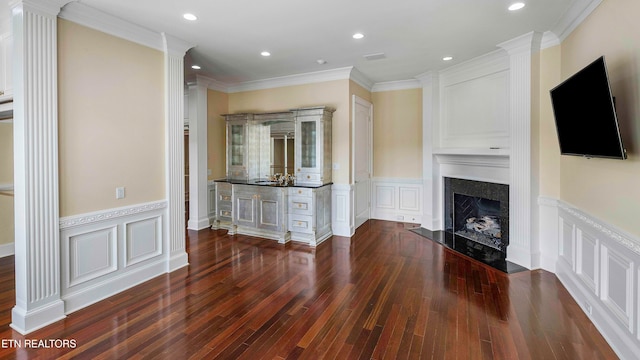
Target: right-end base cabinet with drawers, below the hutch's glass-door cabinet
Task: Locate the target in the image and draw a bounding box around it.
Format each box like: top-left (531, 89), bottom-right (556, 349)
top-left (289, 185), bottom-right (331, 246)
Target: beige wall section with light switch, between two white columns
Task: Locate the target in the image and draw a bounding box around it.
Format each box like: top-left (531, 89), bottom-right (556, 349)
top-left (58, 20), bottom-right (165, 216)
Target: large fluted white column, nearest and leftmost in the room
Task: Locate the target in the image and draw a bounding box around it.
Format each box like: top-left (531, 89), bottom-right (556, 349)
top-left (10, 0), bottom-right (68, 334)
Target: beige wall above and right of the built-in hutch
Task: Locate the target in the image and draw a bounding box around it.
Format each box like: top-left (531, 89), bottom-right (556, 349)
top-left (229, 80), bottom-right (351, 184)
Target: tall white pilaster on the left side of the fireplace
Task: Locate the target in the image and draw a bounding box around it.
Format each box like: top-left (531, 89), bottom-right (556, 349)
top-left (416, 72), bottom-right (443, 230)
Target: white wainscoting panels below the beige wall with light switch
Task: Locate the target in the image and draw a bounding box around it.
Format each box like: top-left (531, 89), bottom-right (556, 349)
top-left (60, 201), bottom-right (169, 314)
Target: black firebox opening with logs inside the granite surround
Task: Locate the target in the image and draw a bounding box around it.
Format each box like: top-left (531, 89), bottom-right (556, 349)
top-left (453, 193), bottom-right (508, 252)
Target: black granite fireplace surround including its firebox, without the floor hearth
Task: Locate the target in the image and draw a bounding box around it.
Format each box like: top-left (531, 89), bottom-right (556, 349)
top-left (444, 177), bottom-right (509, 253)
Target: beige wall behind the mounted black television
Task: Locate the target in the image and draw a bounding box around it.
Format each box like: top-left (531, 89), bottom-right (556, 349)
top-left (560, 0), bottom-right (640, 236)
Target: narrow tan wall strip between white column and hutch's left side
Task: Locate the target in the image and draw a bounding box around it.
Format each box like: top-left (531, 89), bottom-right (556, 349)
top-left (207, 90), bottom-right (229, 180)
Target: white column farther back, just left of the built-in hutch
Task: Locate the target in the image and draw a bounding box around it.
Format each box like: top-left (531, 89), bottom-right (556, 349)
top-left (187, 76), bottom-right (209, 230)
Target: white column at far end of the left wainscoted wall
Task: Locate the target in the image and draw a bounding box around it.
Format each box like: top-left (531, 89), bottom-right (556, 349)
top-left (162, 33), bottom-right (192, 272)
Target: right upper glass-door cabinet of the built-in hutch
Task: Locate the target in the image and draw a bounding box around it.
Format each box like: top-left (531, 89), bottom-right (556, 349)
top-left (291, 106), bottom-right (335, 186)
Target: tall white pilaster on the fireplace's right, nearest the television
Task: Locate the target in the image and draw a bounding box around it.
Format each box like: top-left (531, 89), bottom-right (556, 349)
top-left (498, 32), bottom-right (542, 269)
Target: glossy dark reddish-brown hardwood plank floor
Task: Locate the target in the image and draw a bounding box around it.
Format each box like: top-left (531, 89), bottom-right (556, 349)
top-left (0, 220), bottom-right (616, 359)
